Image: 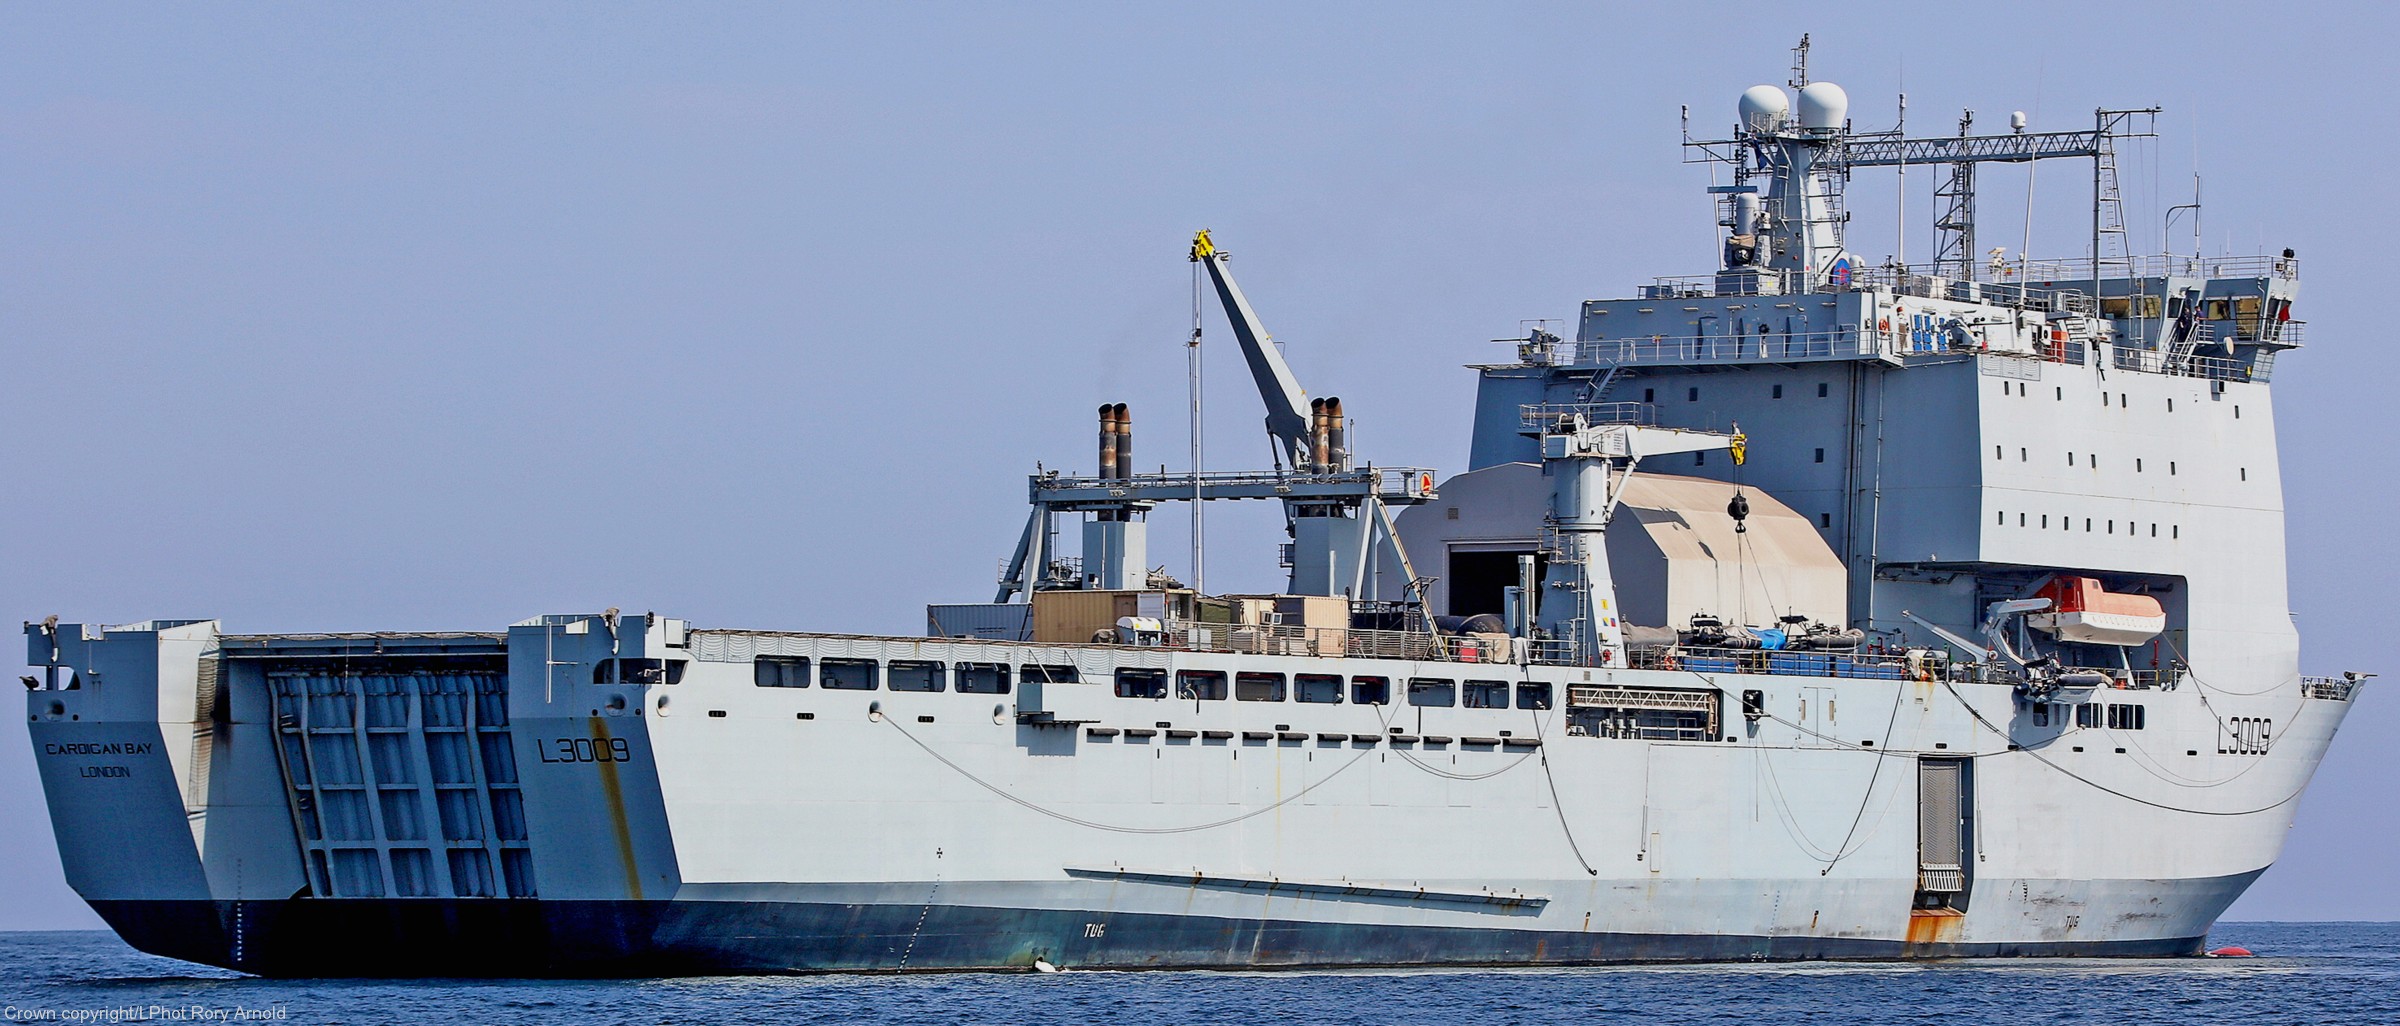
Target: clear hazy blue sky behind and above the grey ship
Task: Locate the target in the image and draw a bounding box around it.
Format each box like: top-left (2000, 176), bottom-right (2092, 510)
top-left (0, 2), bottom-right (2400, 928)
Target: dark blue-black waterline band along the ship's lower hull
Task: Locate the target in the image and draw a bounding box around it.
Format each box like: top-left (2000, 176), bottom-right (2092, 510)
top-left (94, 899), bottom-right (2203, 976)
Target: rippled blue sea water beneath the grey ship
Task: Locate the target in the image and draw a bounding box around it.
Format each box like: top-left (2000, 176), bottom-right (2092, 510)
top-left (0, 923), bottom-right (2400, 1026)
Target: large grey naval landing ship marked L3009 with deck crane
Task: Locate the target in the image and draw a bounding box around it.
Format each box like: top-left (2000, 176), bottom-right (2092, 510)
top-left (24, 50), bottom-right (2366, 976)
